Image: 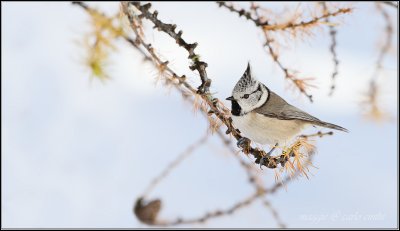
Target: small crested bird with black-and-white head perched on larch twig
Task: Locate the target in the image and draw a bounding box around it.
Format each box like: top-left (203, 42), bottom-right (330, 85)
top-left (226, 62), bottom-right (348, 155)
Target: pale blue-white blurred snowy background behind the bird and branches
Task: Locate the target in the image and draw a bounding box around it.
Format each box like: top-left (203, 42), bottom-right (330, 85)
top-left (1, 2), bottom-right (398, 228)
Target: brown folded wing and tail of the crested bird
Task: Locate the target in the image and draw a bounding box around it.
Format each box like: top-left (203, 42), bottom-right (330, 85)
top-left (254, 90), bottom-right (347, 132)
